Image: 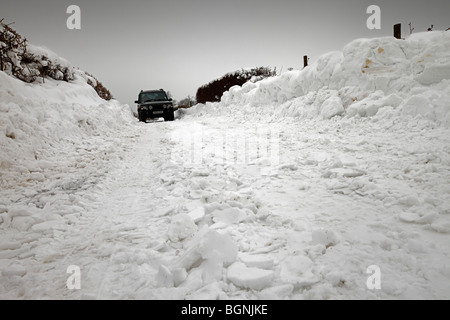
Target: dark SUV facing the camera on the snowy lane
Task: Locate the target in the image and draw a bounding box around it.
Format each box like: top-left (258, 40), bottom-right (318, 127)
top-left (135, 89), bottom-right (175, 122)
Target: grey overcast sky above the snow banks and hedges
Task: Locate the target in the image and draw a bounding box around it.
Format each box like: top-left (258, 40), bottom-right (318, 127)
top-left (0, 0), bottom-right (450, 104)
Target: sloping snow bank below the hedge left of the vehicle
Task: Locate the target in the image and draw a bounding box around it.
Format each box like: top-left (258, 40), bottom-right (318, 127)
top-left (0, 46), bottom-right (132, 188)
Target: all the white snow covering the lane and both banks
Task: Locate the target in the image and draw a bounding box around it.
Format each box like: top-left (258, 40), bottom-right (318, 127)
top-left (0, 32), bottom-right (450, 300)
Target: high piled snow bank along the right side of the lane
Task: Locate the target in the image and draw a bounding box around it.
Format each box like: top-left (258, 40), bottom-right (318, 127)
top-left (183, 31), bottom-right (450, 126)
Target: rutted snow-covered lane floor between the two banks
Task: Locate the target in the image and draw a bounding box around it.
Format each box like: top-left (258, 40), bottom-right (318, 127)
top-left (0, 117), bottom-right (450, 299)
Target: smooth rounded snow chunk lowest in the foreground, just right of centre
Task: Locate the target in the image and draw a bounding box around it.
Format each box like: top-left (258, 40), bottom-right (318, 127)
top-left (227, 262), bottom-right (274, 290)
